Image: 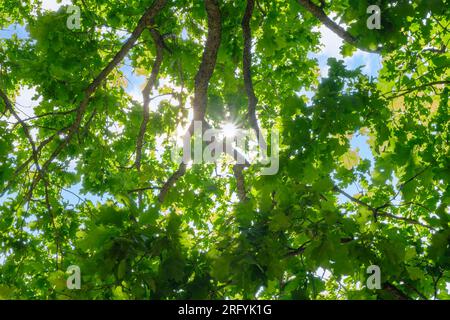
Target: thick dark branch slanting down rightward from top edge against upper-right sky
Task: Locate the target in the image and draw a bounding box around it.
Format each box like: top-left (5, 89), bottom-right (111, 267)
top-left (298, 0), bottom-right (379, 53)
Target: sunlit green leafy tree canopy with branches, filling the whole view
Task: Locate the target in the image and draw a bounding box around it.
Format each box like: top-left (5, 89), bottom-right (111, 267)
top-left (0, 0), bottom-right (450, 299)
